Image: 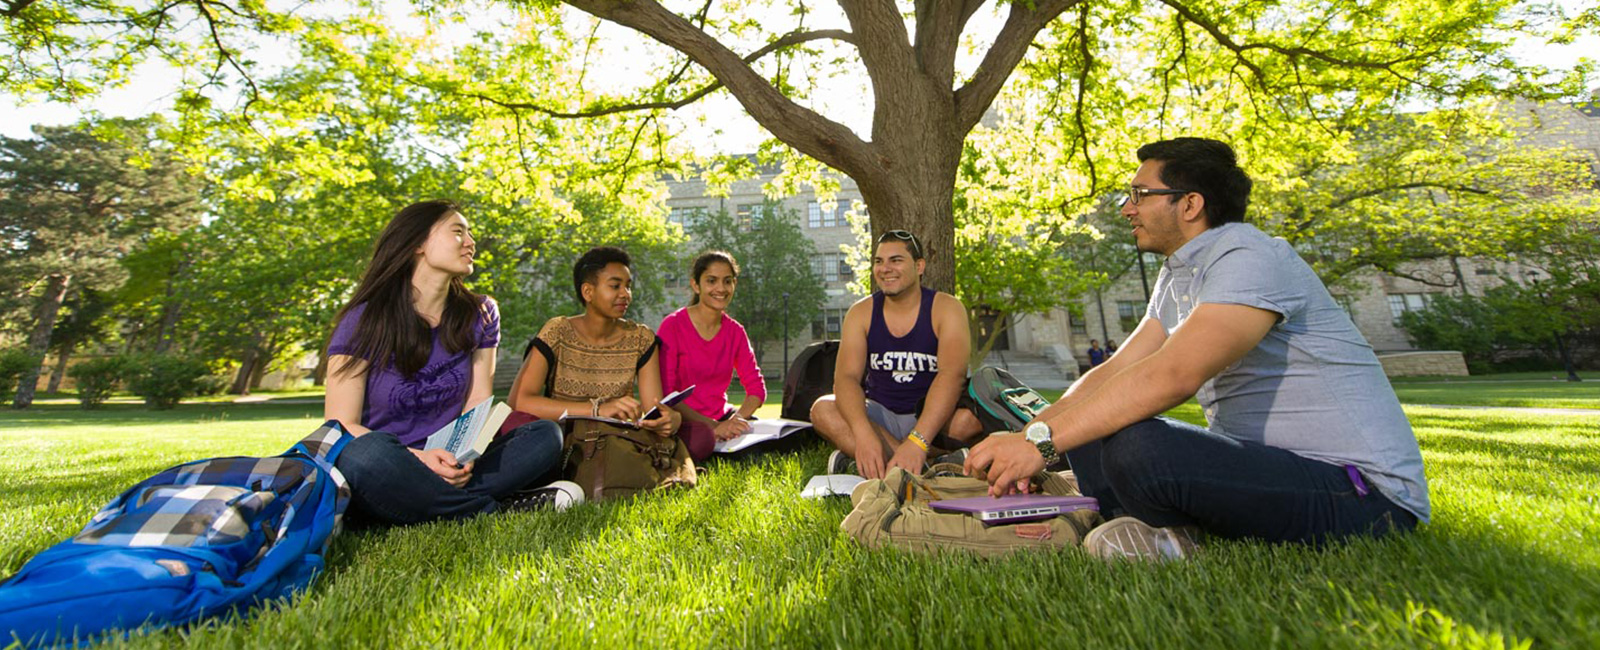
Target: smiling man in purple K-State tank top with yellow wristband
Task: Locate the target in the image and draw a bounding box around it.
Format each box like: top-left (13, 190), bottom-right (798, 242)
top-left (811, 231), bottom-right (982, 479)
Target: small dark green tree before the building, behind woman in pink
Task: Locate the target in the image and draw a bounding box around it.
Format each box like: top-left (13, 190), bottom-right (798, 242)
top-left (675, 202), bottom-right (827, 357)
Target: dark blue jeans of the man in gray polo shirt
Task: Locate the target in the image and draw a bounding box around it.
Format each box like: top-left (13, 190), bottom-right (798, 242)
top-left (1067, 418), bottom-right (1416, 544)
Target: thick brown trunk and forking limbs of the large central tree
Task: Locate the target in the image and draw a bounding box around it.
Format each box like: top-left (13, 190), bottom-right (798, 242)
top-left (563, 0), bottom-right (1078, 297)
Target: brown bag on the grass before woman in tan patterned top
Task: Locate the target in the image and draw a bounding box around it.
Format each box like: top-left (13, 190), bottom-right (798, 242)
top-left (562, 419), bottom-right (694, 501)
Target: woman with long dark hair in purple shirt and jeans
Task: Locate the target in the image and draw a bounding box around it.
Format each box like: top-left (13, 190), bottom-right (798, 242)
top-left (323, 200), bottom-right (582, 524)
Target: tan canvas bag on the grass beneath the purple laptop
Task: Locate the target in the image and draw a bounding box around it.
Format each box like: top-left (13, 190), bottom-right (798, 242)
top-left (840, 466), bottom-right (1101, 557)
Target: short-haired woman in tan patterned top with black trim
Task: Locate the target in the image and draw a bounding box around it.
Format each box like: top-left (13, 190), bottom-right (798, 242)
top-left (509, 247), bottom-right (680, 435)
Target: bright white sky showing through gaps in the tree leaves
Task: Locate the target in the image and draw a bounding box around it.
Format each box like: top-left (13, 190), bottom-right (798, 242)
top-left (0, 0), bottom-right (1600, 155)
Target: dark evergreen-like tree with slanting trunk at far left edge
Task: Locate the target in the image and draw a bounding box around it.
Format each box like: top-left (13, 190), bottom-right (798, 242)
top-left (0, 120), bottom-right (200, 408)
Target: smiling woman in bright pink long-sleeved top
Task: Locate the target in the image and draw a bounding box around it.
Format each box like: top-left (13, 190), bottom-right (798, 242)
top-left (656, 251), bottom-right (766, 461)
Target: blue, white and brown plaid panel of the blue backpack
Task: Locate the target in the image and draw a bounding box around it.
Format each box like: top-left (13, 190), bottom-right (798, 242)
top-left (74, 426), bottom-right (350, 557)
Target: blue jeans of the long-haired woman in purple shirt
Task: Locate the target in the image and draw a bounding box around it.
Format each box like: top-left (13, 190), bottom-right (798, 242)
top-left (334, 419), bottom-right (562, 524)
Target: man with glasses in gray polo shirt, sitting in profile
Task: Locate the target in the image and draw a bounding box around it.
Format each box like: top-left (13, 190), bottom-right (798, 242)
top-left (966, 138), bottom-right (1429, 559)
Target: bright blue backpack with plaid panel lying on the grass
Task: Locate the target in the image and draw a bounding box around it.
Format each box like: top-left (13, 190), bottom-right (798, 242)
top-left (0, 421), bottom-right (352, 645)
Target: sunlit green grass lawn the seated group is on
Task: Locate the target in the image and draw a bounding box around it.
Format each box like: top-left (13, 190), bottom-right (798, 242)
top-left (0, 387), bottom-right (1600, 648)
